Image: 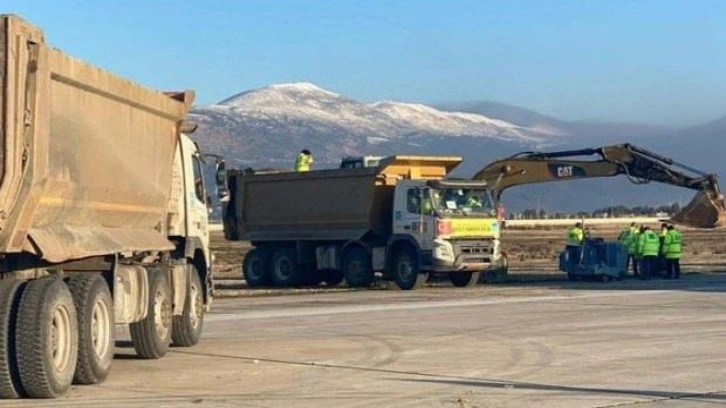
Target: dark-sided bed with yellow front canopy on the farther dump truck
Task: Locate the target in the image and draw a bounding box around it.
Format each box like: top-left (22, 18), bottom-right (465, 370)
top-left (224, 156), bottom-right (461, 242)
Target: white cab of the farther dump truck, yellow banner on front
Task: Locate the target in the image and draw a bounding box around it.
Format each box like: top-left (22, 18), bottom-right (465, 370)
top-left (392, 180), bottom-right (499, 282)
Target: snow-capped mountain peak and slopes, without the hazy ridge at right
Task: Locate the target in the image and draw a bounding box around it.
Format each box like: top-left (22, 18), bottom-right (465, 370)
top-left (192, 83), bottom-right (567, 171)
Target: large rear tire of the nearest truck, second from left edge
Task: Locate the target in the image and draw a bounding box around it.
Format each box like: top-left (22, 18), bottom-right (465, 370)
top-left (15, 277), bottom-right (78, 398)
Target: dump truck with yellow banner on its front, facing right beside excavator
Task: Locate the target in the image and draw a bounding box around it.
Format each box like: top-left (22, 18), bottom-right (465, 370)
top-left (218, 155), bottom-right (499, 290)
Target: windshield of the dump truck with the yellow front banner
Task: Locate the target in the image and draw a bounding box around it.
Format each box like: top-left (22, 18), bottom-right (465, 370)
top-left (431, 188), bottom-right (496, 216)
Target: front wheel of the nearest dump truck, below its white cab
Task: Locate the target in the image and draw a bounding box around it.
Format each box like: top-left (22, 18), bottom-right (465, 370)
top-left (171, 265), bottom-right (204, 347)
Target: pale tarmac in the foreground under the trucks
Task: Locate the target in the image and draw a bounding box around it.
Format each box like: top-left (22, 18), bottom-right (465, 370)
top-left (5, 274), bottom-right (726, 408)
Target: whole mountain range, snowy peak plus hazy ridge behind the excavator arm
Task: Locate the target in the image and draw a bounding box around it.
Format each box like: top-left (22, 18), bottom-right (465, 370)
top-left (190, 83), bottom-right (726, 210)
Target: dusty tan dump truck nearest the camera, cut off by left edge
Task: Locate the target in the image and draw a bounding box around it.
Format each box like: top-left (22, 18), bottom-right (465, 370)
top-left (0, 15), bottom-right (212, 399)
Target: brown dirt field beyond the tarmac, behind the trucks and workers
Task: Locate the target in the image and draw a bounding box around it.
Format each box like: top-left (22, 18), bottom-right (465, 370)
top-left (212, 224), bottom-right (726, 279)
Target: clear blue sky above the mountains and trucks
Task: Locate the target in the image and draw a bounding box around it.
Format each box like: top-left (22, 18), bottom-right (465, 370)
top-left (2, 0), bottom-right (726, 125)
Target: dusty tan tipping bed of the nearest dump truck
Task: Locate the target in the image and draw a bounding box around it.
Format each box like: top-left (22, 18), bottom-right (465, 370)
top-left (0, 15), bottom-right (193, 262)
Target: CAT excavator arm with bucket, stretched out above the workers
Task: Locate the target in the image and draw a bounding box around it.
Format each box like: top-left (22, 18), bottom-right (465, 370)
top-left (473, 144), bottom-right (726, 228)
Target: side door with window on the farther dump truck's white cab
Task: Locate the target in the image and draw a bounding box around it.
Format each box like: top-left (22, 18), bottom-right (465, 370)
top-left (393, 187), bottom-right (435, 251)
